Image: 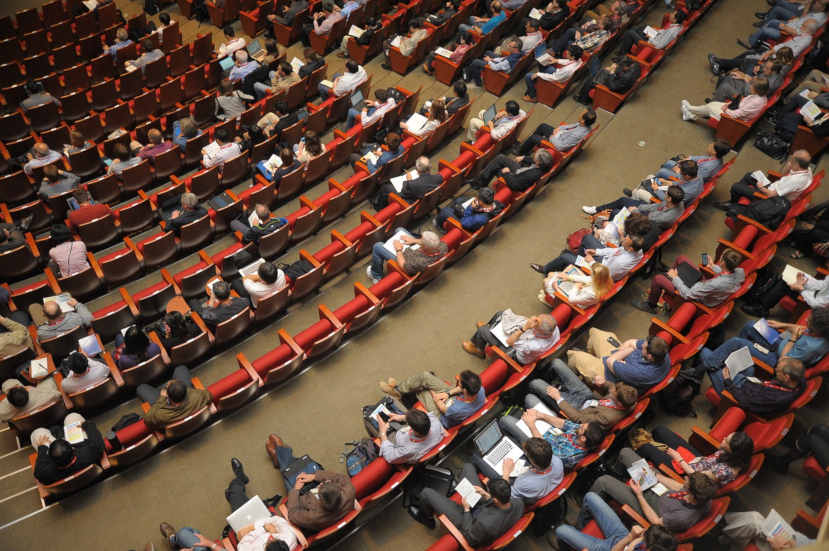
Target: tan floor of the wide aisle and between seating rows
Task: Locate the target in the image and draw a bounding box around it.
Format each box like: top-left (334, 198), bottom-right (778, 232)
top-left (0, 0), bottom-right (829, 551)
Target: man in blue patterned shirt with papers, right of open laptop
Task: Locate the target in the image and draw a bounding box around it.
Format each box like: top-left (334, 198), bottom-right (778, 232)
top-left (498, 406), bottom-right (605, 471)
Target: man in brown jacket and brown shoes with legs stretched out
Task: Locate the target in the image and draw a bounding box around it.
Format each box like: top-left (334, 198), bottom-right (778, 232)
top-left (265, 434), bottom-right (356, 532)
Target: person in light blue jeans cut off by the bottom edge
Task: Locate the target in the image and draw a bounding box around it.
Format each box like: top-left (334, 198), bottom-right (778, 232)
top-left (555, 492), bottom-right (678, 551)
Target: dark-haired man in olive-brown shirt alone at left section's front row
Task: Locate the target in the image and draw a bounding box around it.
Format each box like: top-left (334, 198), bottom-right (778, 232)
top-left (135, 365), bottom-right (213, 430)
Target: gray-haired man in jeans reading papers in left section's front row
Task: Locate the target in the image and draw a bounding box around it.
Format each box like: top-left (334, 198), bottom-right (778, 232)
top-left (366, 228), bottom-right (449, 283)
